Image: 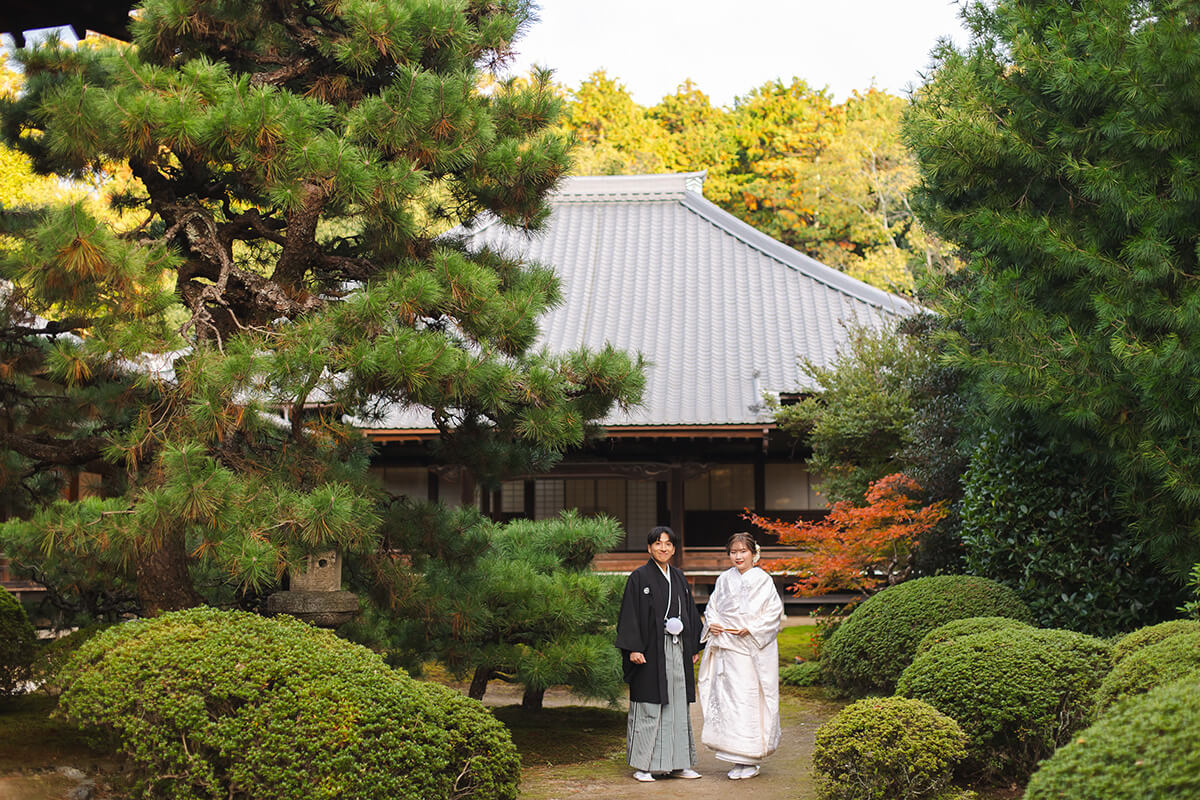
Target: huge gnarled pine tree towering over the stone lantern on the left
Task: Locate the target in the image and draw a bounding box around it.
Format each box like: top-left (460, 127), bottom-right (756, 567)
top-left (0, 0), bottom-right (642, 613)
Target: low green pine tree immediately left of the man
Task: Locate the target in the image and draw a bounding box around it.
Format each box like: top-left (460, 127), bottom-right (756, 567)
top-left (346, 510), bottom-right (624, 710)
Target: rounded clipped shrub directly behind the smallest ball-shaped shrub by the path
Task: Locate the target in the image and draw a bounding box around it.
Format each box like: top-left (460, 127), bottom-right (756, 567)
top-left (896, 627), bottom-right (1111, 778)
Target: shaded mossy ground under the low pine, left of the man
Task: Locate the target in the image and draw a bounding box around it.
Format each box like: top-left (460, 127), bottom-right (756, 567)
top-left (492, 705), bottom-right (625, 766)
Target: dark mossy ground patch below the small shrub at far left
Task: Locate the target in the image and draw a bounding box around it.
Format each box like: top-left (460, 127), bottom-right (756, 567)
top-left (0, 694), bottom-right (112, 774)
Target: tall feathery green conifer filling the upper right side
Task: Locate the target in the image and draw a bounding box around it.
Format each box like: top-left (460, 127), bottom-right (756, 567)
top-left (905, 0), bottom-right (1200, 575)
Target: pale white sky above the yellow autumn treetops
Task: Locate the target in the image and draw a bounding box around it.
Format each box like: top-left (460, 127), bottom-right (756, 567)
top-left (501, 0), bottom-right (966, 106)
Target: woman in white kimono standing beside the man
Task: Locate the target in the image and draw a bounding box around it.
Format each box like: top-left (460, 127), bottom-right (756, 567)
top-left (698, 534), bottom-right (784, 781)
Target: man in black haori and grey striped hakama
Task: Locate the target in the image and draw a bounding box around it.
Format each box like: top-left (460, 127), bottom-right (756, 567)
top-left (617, 528), bottom-right (701, 781)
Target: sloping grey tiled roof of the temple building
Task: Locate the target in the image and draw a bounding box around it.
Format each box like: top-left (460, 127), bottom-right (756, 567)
top-left (371, 173), bottom-right (917, 428)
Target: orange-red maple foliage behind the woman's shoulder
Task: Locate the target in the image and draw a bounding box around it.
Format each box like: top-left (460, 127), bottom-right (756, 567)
top-left (745, 473), bottom-right (947, 596)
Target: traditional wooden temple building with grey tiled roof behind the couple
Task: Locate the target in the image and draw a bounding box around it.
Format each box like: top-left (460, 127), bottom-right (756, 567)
top-left (367, 173), bottom-right (918, 594)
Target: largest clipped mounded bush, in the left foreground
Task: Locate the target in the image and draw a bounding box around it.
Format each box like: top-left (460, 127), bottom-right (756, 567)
top-left (59, 608), bottom-right (520, 800)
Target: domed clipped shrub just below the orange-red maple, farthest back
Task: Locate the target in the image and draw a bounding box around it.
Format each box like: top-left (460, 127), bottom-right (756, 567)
top-left (821, 575), bottom-right (1031, 693)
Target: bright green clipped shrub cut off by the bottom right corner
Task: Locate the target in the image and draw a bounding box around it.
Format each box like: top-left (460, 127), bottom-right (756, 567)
top-left (1025, 676), bottom-right (1200, 800)
